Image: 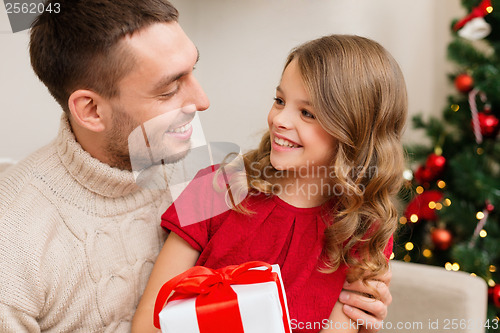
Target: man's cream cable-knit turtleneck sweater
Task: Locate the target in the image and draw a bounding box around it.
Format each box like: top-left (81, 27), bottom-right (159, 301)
top-left (0, 116), bottom-right (170, 333)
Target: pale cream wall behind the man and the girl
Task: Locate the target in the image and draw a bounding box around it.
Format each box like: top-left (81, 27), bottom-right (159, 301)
top-left (0, 0), bottom-right (464, 160)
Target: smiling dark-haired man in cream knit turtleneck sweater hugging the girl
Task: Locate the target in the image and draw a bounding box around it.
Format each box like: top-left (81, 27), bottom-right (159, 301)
top-left (0, 0), bottom-right (390, 333)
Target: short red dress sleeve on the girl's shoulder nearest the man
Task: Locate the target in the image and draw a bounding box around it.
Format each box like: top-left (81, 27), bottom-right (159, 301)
top-left (161, 166), bottom-right (230, 252)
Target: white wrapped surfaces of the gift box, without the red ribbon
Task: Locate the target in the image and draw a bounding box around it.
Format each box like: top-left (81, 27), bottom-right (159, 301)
top-left (159, 265), bottom-right (291, 333)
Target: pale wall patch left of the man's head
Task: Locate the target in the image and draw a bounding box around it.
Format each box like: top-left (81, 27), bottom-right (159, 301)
top-left (0, 8), bottom-right (61, 160)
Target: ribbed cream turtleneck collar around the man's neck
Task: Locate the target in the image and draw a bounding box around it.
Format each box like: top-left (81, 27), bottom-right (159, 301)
top-left (56, 113), bottom-right (140, 198)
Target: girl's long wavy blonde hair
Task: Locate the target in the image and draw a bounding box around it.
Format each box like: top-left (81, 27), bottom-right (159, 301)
top-left (240, 35), bottom-right (408, 281)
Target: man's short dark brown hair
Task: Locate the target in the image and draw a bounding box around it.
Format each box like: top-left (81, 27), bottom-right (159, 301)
top-left (30, 0), bottom-right (179, 112)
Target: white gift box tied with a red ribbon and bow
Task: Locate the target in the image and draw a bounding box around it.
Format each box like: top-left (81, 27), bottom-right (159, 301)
top-left (154, 262), bottom-right (291, 333)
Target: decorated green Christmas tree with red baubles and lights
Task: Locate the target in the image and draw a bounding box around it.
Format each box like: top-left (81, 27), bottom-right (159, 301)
top-left (395, 0), bottom-right (500, 331)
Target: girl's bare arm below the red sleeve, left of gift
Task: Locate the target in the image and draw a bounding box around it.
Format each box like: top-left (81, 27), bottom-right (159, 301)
top-left (132, 232), bottom-right (200, 333)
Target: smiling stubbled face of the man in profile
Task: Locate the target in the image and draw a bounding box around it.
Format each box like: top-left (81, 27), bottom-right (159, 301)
top-left (105, 22), bottom-right (209, 170)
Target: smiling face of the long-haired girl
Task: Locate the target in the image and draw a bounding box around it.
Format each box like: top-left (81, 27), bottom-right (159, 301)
top-left (267, 60), bottom-right (336, 177)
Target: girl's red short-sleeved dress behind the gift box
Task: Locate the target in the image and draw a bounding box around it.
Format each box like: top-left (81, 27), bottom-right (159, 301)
top-left (161, 167), bottom-right (392, 333)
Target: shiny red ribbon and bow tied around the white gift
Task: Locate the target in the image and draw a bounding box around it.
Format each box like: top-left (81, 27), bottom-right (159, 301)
top-left (153, 261), bottom-right (290, 333)
